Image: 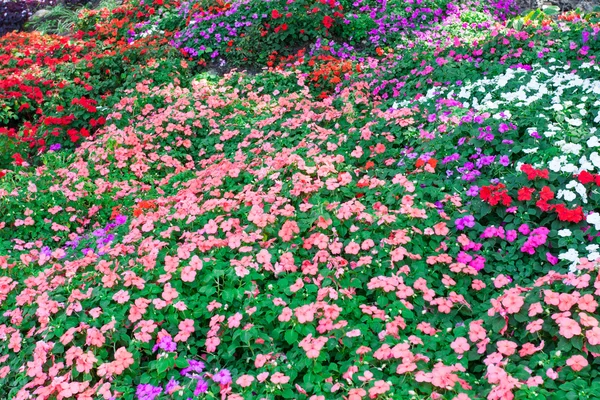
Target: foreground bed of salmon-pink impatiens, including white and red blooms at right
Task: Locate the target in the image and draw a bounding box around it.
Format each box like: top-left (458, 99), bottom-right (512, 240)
top-left (0, 10), bottom-right (600, 400)
